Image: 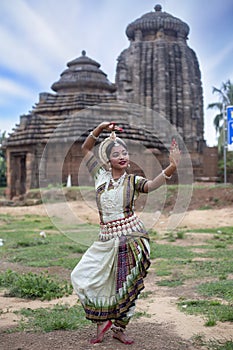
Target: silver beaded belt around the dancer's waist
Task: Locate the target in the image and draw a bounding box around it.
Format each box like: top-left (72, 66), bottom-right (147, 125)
top-left (99, 214), bottom-right (144, 241)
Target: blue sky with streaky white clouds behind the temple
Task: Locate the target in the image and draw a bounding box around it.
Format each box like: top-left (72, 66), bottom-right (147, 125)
top-left (0, 0), bottom-right (233, 146)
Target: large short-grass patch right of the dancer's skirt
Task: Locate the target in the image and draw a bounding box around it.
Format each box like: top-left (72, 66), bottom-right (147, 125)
top-left (151, 227), bottom-right (233, 279)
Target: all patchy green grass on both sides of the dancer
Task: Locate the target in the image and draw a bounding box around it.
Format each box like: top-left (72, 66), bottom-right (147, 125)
top-left (0, 211), bottom-right (233, 349)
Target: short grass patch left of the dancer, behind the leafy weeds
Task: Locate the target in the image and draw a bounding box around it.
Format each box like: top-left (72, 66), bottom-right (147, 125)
top-left (0, 215), bottom-right (87, 269)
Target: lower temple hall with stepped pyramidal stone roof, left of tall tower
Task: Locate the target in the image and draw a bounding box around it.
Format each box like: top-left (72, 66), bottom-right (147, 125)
top-left (4, 51), bottom-right (116, 198)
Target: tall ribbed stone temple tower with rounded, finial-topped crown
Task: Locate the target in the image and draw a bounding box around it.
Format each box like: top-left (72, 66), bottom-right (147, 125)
top-left (116, 5), bottom-right (204, 153)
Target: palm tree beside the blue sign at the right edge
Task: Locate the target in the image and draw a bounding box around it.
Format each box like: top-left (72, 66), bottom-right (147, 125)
top-left (207, 80), bottom-right (233, 153)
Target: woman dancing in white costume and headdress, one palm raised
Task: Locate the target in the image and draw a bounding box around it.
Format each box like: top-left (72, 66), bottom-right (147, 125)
top-left (71, 122), bottom-right (180, 344)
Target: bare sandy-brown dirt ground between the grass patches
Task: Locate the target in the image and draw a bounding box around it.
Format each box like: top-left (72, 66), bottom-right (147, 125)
top-left (0, 188), bottom-right (233, 350)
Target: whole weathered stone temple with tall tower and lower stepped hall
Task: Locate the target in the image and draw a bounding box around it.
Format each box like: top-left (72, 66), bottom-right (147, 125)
top-left (3, 5), bottom-right (217, 198)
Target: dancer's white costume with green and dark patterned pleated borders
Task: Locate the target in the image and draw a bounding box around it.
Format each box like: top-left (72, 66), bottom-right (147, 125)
top-left (71, 132), bottom-right (150, 329)
